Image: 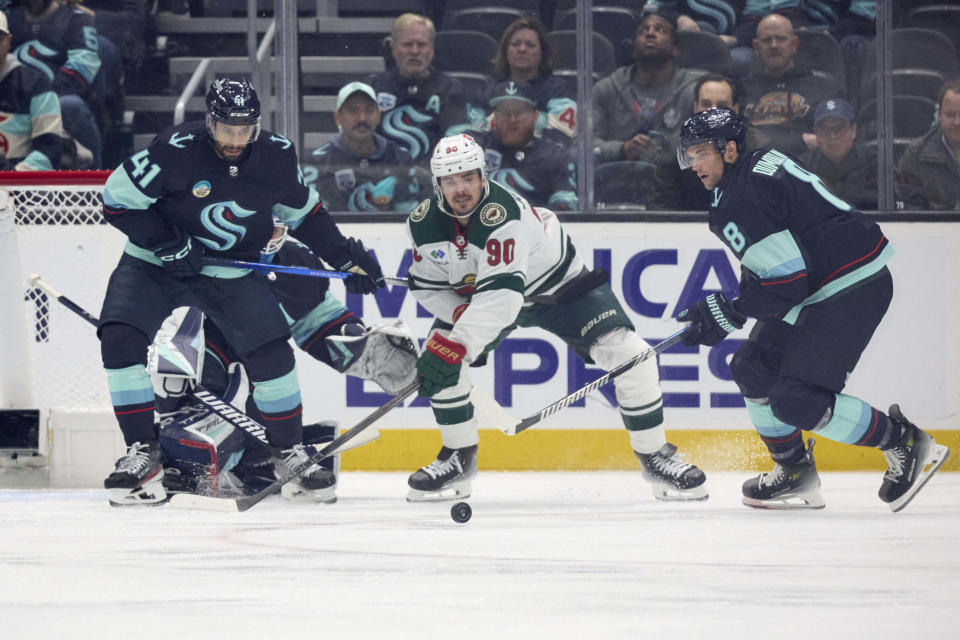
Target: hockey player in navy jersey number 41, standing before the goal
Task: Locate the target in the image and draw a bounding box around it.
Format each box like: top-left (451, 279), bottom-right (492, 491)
top-left (99, 79), bottom-right (384, 504)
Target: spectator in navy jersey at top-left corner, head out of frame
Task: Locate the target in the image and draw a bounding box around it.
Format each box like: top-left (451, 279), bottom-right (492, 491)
top-left (7, 0), bottom-right (102, 169)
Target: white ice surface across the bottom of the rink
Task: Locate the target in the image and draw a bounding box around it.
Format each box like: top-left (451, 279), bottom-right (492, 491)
top-left (0, 472), bottom-right (960, 640)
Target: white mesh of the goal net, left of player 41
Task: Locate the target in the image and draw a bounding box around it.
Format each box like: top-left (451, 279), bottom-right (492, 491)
top-left (0, 172), bottom-right (116, 411)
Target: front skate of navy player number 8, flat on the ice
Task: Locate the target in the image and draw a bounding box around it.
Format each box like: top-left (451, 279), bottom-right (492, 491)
top-left (743, 438), bottom-right (827, 509)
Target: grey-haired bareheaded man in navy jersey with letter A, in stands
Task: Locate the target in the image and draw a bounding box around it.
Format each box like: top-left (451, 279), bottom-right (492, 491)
top-left (370, 13), bottom-right (470, 162)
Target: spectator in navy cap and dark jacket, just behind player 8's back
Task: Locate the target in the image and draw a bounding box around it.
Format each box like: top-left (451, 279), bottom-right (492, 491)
top-left (800, 98), bottom-right (877, 210)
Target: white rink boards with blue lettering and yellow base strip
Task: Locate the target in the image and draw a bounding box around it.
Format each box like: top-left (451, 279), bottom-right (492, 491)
top-left (0, 222), bottom-right (960, 484)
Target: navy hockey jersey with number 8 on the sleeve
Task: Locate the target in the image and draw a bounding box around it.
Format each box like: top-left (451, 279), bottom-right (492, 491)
top-left (709, 149), bottom-right (893, 324)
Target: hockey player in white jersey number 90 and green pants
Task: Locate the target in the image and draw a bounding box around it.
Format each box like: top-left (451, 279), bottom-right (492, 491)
top-left (407, 135), bottom-right (707, 501)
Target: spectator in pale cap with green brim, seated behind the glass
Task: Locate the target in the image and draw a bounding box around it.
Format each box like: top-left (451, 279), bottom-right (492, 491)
top-left (304, 82), bottom-right (430, 211)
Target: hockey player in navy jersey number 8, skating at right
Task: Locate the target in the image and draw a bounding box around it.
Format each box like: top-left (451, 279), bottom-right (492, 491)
top-left (677, 108), bottom-right (949, 511)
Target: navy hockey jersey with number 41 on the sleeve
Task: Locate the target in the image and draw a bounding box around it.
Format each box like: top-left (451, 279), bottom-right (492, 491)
top-left (103, 122), bottom-right (348, 277)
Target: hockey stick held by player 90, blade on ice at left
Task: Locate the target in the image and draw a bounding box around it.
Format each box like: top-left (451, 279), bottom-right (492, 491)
top-left (170, 380), bottom-right (420, 512)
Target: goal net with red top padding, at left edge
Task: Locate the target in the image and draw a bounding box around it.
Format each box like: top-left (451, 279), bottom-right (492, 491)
top-left (0, 171), bottom-right (119, 412)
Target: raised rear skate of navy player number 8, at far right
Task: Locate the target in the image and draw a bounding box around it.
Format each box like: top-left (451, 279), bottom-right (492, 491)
top-left (879, 405), bottom-right (950, 512)
